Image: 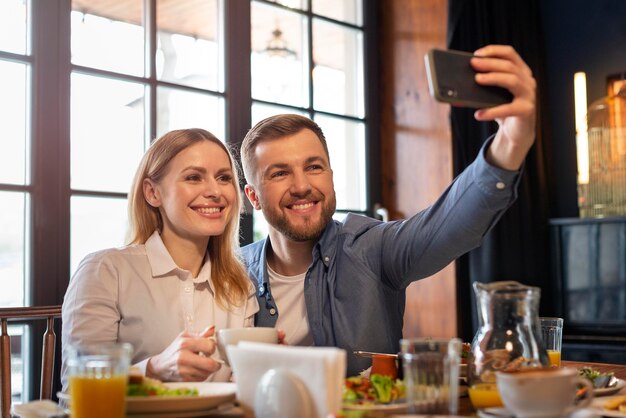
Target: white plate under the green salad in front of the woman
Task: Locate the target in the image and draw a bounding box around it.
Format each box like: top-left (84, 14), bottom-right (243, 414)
top-left (57, 382), bottom-right (237, 418)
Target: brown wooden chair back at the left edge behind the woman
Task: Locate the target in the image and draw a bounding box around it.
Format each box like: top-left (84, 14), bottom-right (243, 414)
top-left (0, 305), bottom-right (61, 418)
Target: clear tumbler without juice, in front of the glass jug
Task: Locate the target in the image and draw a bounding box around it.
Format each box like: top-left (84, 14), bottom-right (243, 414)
top-left (400, 338), bottom-right (461, 415)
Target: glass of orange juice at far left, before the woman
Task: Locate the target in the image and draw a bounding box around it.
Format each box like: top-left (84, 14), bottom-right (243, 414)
top-left (67, 343), bottom-right (132, 418)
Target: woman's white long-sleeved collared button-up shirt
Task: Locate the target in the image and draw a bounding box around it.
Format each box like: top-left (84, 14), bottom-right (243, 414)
top-left (61, 232), bottom-right (259, 389)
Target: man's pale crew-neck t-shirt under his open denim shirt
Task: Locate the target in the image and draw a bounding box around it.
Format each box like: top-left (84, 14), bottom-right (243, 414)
top-left (267, 264), bottom-right (313, 346)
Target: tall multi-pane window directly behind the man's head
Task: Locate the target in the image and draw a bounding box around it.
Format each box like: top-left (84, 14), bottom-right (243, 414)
top-left (251, 0), bottom-right (369, 240)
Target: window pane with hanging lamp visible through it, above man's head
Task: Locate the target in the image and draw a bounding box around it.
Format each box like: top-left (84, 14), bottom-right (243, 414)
top-left (250, 2), bottom-right (309, 107)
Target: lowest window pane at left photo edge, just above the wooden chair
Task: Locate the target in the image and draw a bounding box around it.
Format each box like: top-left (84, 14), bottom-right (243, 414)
top-left (0, 192), bottom-right (27, 307)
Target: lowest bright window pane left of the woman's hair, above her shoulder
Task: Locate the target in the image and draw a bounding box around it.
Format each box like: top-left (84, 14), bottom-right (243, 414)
top-left (70, 196), bottom-right (128, 274)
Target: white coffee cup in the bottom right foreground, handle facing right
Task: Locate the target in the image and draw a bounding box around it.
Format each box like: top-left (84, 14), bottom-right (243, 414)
top-left (496, 367), bottom-right (593, 418)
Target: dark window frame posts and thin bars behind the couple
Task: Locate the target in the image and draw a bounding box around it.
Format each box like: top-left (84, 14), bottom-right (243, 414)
top-left (0, 0), bottom-right (381, 399)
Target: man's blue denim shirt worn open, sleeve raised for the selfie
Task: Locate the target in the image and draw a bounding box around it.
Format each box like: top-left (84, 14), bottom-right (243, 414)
top-left (242, 138), bottom-right (520, 376)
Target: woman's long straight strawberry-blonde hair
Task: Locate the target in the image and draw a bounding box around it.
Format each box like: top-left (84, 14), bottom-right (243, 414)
top-left (128, 128), bottom-right (250, 309)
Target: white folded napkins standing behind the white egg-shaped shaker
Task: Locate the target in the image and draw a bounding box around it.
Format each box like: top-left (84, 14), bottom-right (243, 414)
top-left (226, 341), bottom-right (346, 418)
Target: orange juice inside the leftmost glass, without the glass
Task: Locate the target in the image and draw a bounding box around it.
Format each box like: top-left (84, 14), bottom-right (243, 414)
top-left (70, 375), bottom-right (128, 418)
